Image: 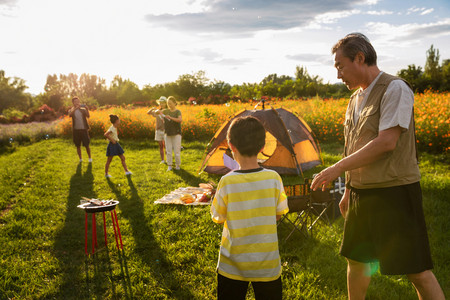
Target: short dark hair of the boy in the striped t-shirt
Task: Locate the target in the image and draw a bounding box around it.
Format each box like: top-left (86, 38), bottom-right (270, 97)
top-left (227, 116), bottom-right (266, 156)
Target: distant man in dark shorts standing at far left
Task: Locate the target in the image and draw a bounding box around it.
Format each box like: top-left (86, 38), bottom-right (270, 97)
top-left (69, 97), bottom-right (92, 162)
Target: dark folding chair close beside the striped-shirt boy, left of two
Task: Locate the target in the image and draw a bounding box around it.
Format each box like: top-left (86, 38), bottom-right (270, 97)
top-left (277, 180), bottom-right (311, 242)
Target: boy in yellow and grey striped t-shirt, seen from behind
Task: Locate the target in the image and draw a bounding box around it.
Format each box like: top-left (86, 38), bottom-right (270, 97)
top-left (211, 116), bottom-right (289, 300)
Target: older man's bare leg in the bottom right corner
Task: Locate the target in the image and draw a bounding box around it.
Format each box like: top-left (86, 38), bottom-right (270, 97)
top-left (406, 270), bottom-right (445, 300)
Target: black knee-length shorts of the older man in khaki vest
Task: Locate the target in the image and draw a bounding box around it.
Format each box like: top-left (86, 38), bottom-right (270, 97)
top-left (340, 182), bottom-right (433, 275)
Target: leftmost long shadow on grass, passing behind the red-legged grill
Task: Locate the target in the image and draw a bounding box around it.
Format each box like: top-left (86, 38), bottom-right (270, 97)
top-left (52, 163), bottom-right (131, 299)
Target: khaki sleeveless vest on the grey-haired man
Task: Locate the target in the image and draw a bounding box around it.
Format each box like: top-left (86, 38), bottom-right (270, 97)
top-left (344, 73), bottom-right (420, 189)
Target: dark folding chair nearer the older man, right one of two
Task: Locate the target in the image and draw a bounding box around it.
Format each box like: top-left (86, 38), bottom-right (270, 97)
top-left (308, 177), bottom-right (345, 235)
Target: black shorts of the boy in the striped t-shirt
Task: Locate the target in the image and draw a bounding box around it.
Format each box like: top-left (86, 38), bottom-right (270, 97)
top-left (217, 273), bottom-right (283, 300)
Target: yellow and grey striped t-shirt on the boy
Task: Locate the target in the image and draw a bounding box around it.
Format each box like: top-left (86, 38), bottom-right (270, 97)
top-left (211, 168), bottom-right (289, 281)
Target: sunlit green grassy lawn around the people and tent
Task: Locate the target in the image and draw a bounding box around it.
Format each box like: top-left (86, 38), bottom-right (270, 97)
top-left (0, 139), bottom-right (450, 299)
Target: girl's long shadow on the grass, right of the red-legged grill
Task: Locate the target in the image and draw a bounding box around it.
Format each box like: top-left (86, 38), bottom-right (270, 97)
top-left (107, 176), bottom-right (195, 299)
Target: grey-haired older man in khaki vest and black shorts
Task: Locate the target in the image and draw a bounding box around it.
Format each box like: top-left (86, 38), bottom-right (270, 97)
top-left (311, 33), bottom-right (444, 300)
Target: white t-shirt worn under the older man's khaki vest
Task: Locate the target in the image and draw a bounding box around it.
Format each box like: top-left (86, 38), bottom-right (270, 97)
top-left (354, 72), bottom-right (414, 131)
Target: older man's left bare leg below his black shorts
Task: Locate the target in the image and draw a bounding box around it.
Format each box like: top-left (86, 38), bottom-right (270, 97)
top-left (347, 259), bottom-right (370, 300)
